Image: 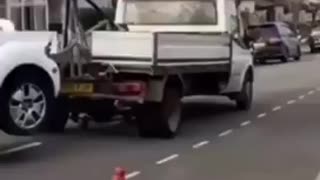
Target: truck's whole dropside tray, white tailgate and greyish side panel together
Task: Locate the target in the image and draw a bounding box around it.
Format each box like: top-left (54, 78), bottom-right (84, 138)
top-left (92, 31), bottom-right (231, 75)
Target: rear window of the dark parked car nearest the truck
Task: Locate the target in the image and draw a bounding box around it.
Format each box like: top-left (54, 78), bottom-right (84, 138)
top-left (249, 25), bottom-right (278, 40)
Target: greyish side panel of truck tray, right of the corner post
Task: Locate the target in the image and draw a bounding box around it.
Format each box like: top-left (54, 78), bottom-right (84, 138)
top-left (156, 33), bottom-right (230, 65)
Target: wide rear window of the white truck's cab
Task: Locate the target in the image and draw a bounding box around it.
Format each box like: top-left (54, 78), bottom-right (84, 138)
top-left (125, 0), bottom-right (217, 25)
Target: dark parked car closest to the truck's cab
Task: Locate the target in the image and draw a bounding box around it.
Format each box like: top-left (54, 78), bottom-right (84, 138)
top-left (249, 22), bottom-right (301, 63)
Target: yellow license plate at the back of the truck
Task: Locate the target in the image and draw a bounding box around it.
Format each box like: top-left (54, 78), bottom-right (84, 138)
top-left (62, 83), bottom-right (94, 93)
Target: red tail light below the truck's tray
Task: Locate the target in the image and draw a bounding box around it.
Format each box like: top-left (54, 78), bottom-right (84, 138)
top-left (113, 82), bottom-right (146, 96)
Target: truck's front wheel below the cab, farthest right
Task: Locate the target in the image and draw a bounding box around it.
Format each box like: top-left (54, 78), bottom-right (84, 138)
top-left (235, 74), bottom-right (253, 110)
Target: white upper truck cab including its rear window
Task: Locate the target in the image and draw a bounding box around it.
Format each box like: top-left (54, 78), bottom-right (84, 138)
top-left (115, 0), bottom-right (237, 32)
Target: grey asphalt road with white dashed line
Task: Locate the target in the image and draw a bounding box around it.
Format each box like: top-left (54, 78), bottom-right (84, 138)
top-left (0, 54), bottom-right (320, 180)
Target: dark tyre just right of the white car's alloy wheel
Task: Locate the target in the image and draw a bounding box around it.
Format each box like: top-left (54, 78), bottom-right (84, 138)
top-left (47, 96), bottom-right (70, 133)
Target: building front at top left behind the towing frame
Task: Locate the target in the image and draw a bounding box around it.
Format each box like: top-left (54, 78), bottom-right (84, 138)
top-left (0, 0), bottom-right (111, 30)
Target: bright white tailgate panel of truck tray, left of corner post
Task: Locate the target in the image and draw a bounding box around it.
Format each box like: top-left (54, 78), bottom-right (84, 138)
top-left (92, 31), bottom-right (153, 65)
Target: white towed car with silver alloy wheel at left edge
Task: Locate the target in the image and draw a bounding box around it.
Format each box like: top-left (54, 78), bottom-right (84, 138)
top-left (0, 19), bottom-right (60, 134)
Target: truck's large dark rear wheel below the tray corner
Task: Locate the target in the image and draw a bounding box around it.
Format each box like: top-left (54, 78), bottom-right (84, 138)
top-left (137, 87), bottom-right (182, 139)
